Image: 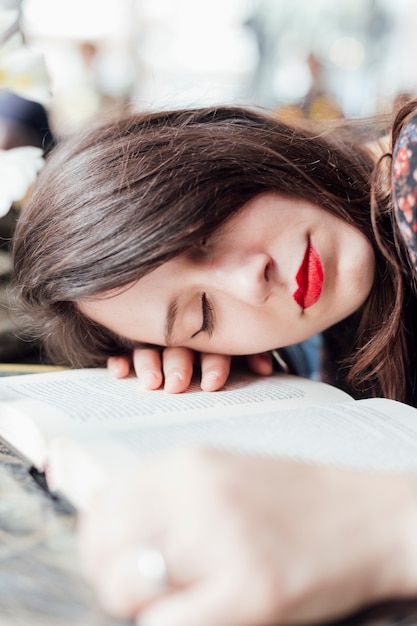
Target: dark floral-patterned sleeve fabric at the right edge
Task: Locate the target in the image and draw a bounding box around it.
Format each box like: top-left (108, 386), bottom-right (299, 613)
top-left (392, 115), bottom-right (417, 270)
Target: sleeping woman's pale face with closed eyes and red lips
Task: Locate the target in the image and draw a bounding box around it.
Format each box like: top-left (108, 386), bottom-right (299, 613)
top-left (79, 193), bottom-right (374, 355)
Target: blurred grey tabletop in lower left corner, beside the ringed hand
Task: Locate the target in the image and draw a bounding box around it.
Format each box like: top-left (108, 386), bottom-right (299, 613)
top-left (0, 444), bottom-right (132, 626)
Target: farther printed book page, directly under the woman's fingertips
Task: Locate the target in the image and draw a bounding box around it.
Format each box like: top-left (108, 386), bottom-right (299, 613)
top-left (0, 369), bottom-right (351, 429)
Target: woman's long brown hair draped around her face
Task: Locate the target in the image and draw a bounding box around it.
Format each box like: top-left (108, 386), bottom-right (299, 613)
top-left (14, 107), bottom-right (417, 402)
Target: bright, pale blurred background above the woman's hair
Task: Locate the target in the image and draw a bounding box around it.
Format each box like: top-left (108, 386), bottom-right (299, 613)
top-left (0, 0), bottom-right (417, 135)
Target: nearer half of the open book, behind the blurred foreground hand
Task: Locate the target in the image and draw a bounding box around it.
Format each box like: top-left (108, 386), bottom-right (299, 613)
top-left (43, 399), bottom-right (417, 508)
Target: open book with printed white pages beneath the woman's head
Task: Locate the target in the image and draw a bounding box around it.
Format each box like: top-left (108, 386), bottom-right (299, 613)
top-left (0, 369), bottom-right (417, 507)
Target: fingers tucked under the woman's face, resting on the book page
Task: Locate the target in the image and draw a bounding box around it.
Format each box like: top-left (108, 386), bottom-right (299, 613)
top-left (107, 348), bottom-right (272, 393)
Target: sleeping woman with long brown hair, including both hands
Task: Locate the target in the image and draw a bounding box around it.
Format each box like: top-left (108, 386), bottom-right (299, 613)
top-left (9, 103), bottom-right (417, 626)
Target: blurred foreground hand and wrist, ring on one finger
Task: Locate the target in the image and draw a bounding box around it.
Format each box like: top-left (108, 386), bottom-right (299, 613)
top-left (79, 450), bottom-right (417, 626)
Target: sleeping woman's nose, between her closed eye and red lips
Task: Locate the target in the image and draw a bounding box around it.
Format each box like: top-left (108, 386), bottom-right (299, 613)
top-left (202, 252), bottom-right (274, 306)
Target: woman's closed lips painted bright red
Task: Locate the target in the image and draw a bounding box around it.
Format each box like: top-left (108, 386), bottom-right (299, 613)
top-left (293, 239), bottom-right (324, 310)
